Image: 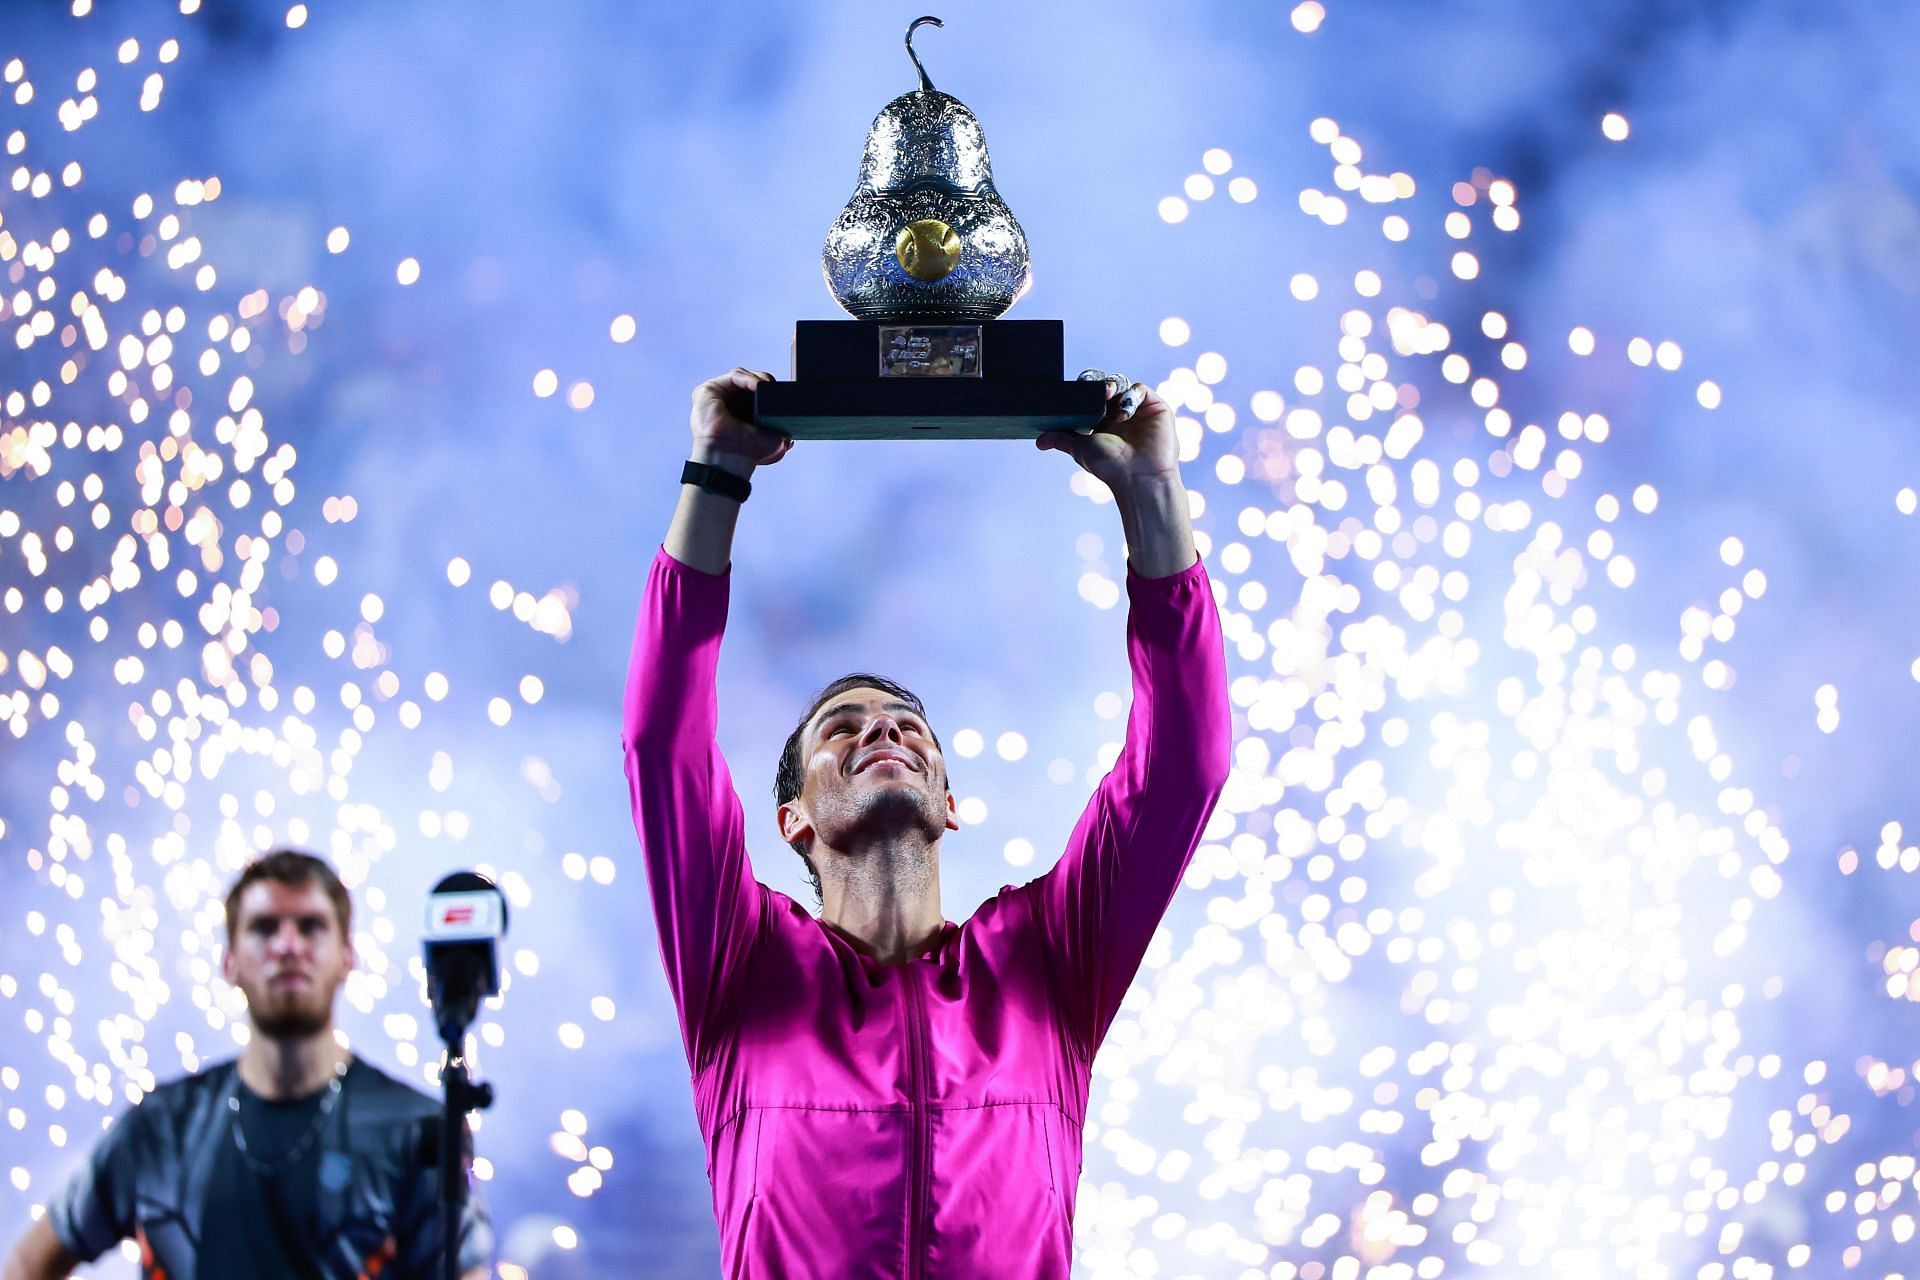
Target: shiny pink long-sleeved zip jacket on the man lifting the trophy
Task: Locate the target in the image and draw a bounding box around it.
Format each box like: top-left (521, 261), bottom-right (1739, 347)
top-left (626, 551), bottom-right (1231, 1280)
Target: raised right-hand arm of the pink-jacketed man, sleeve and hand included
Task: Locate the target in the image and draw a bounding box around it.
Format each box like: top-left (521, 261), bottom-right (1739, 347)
top-left (1031, 384), bottom-right (1233, 1054)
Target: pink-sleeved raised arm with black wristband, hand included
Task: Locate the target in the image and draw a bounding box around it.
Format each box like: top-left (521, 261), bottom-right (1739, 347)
top-left (622, 368), bottom-right (791, 1071)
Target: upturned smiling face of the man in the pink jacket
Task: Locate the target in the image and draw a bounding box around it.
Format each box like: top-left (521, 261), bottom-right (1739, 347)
top-left (780, 687), bottom-right (960, 850)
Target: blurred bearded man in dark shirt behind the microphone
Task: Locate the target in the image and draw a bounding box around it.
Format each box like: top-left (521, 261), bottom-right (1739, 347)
top-left (4, 850), bottom-right (493, 1280)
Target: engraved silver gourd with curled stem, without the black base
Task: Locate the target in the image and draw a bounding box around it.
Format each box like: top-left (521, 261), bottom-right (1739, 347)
top-left (822, 17), bottom-right (1031, 320)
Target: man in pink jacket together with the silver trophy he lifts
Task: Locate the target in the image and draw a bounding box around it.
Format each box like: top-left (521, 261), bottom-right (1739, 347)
top-left (624, 19), bottom-right (1231, 1280)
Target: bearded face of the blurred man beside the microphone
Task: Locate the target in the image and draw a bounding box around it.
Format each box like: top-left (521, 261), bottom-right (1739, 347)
top-left (221, 879), bottom-right (353, 1038)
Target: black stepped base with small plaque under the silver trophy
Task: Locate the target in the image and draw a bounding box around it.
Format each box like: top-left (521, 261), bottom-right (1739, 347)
top-left (753, 320), bottom-right (1106, 439)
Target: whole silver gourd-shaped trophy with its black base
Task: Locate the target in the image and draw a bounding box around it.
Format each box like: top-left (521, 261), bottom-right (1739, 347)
top-left (753, 17), bottom-right (1108, 439)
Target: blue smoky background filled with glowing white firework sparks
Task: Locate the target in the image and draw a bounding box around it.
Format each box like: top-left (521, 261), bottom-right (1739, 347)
top-left (0, 0), bottom-right (1920, 1280)
